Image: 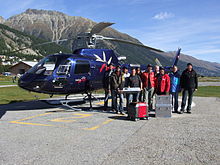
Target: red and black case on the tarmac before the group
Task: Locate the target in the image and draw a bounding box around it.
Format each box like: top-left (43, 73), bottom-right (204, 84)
top-left (128, 102), bottom-right (148, 121)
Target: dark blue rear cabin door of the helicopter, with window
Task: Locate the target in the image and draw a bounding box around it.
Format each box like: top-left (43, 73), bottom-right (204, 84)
top-left (74, 60), bottom-right (91, 92)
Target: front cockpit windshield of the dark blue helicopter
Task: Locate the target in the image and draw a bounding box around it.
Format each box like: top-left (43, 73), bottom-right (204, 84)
top-left (28, 56), bottom-right (57, 75)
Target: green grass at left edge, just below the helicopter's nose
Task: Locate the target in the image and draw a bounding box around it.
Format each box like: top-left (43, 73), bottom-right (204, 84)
top-left (0, 87), bottom-right (49, 104)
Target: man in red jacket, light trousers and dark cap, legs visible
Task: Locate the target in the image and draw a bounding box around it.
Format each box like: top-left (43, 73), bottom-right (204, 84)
top-left (141, 64), bottom-right (155, 111)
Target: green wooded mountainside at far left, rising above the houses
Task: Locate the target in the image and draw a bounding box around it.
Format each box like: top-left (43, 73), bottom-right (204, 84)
top-left (0, 24), bottom-right (70, 60)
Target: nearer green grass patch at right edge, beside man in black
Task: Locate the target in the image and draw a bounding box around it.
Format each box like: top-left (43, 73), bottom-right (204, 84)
top-left (194, 86), bottom-right (220, 97)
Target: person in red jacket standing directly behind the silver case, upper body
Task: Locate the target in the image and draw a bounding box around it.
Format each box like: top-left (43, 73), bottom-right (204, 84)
top-left (156, 67), bottom-right (170, 95)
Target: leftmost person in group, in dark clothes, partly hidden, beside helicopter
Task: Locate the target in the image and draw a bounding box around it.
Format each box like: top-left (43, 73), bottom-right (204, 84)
top-left (103, 64), bottom-right (114, 110)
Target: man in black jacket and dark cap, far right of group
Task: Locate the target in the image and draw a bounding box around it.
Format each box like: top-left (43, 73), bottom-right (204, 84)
top-left (180, 63), bottom-right (198, 113)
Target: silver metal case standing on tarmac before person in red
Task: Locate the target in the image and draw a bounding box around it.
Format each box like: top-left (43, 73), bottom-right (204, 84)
top-left (155, 95), bottom-right (173, 118)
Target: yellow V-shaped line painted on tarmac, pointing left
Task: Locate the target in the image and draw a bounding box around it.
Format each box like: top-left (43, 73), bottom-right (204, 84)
top-left (10, 112), bottom-right (54, 127)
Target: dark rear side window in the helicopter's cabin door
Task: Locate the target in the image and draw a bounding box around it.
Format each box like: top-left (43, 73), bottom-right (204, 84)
top-left (74, 60), bottom-right (90, 74)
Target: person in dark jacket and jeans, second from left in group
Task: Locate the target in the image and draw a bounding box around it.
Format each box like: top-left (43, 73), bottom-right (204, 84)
top-left (110, 66), bottom-right (124, 115)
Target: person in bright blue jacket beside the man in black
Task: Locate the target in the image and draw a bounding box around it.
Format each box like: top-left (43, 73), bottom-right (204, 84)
top-left (169, 66), bottom-right (181, 113)
